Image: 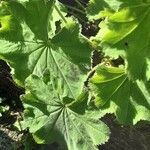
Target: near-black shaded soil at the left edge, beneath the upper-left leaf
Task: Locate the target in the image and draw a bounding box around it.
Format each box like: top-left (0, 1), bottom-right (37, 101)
top-left (0, 60), bottom-right (24, 109)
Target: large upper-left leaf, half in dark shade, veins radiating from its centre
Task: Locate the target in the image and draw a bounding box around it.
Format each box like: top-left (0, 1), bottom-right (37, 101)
top-left (0, 0), bottom-right (91, 90)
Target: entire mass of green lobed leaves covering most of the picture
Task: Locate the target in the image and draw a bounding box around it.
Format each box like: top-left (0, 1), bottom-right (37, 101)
top-left (0, 0), bottom-right (150, 150)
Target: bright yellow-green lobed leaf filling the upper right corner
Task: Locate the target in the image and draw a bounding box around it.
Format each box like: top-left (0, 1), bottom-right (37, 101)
top-left (87, 0), bottom-right (150, 80)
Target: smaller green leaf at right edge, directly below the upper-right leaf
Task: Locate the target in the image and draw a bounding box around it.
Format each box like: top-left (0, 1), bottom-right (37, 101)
top-left (90, 66), bottom-right (150, 124)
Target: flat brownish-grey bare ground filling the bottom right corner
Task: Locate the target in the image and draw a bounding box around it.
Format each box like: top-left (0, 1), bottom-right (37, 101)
top-left (100, 115), bottom-right (150, 150)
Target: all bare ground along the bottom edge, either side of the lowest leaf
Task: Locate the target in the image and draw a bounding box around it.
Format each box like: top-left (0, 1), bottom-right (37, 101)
top-left (0, 115), bottom-right (150, 150)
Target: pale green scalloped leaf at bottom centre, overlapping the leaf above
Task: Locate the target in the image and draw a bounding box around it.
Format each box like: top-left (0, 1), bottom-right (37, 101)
top-left (22, 75), bottom-right (109, 150)
